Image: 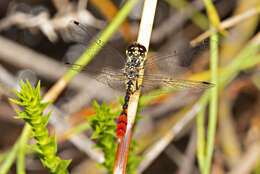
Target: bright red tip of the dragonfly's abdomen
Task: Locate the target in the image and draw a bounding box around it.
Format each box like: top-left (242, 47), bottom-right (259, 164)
top-left (116, 109), bottom-right (127, 140)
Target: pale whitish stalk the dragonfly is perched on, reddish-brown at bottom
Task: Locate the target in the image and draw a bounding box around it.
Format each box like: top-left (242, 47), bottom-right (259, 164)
top-left (113, 0), bottom-right (157, 174)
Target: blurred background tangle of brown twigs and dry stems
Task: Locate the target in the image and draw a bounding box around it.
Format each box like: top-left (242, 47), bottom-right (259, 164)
top-left (0, 0), bottom-right (260, 174)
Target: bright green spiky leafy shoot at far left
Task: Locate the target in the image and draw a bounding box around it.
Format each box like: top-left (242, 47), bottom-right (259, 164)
top-left (10, 80), bottom-right (70, 174)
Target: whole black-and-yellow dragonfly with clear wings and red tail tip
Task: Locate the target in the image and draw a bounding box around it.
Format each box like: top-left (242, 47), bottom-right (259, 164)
top-left (64, 21), bottom-right (212, 141)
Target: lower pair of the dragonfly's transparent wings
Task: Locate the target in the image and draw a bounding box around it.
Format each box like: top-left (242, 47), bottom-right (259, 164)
top-left (65, 61), bottom-right (214, 93)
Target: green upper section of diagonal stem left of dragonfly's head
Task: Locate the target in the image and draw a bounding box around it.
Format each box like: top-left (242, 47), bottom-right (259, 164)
top-left (65, 0), bottom-right (138, 81)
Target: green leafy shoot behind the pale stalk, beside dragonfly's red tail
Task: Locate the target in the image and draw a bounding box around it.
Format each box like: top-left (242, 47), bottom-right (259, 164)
top-left (87, 100), bottom-right (141, 174)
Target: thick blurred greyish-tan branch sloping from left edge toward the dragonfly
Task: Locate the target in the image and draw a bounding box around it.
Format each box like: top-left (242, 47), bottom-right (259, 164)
top-left (0, 37), bottom-right (114, 103)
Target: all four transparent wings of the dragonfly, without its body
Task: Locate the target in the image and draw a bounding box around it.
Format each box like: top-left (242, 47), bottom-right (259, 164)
top-left (63, 21), bottom-right (213, 95)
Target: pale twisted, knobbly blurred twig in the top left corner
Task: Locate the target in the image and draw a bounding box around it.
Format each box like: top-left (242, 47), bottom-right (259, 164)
top-left (0, 1), bottom-right (105, 42)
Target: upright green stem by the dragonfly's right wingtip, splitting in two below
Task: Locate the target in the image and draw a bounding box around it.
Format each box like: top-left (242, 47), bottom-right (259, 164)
top-left (197, 0), bottom-right (219, 174)
